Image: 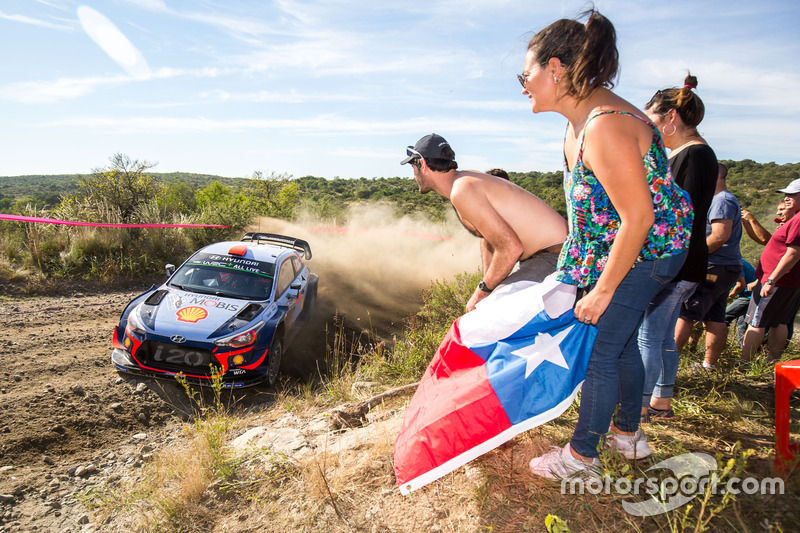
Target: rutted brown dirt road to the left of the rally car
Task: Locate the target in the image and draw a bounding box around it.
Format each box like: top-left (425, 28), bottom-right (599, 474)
top-left (0, 284), bottom-right (184, 531)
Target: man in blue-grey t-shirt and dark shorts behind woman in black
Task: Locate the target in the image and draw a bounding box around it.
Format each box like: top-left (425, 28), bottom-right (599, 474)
top-left (675, 163), bottom-right (742, 370)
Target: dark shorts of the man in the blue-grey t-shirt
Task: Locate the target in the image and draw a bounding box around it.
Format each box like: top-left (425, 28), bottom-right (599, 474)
top-left (681, 263), bottom-right (742, 323)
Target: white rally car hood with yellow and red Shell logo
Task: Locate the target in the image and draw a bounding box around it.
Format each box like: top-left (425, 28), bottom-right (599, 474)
top-left (148, 289), bottom-right (263, 340)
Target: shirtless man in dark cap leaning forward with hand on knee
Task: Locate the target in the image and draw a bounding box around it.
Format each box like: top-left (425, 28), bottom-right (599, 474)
top-left (400, 133), bottom-right (567, 311)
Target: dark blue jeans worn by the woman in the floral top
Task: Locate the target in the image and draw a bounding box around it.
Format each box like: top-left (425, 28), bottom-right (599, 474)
top-left (570, 252), bottom-right (686, 457)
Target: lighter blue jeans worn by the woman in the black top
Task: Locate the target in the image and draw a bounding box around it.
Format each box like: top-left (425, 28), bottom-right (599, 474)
top-left (639, 281), bottom-right (698, 407)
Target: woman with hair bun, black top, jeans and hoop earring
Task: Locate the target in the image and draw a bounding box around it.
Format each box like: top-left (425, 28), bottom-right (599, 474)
top-left (639, 76), bottom-right (718, 422)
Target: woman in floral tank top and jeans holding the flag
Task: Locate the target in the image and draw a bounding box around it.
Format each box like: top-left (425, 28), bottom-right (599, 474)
top-left (518, 10), bottom-right (693, 478)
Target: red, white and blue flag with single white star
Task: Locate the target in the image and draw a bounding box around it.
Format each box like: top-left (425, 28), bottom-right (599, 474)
top-left (394, 274), bottom-right (597, 494)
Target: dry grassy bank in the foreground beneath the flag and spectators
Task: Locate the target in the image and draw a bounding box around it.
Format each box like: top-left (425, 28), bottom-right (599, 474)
top-left (86, 290), bottom-right (800, 533)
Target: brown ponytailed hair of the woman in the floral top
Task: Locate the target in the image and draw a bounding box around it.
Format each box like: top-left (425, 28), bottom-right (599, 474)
top-left (528, 9), bottom-right (619, 100)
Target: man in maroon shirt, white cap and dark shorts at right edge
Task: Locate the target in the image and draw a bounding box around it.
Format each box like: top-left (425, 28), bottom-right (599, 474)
top-left (742, 179), bottom-right (800, 362)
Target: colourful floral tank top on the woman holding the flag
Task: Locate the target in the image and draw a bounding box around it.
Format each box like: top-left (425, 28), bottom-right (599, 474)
top-left (557, 111), bottom-right (694, 287)
